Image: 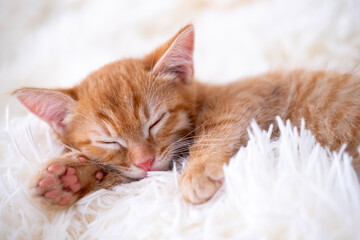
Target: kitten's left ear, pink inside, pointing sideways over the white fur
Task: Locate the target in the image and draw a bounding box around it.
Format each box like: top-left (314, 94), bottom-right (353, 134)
top-left (13, 88), bottom-right (75, 135)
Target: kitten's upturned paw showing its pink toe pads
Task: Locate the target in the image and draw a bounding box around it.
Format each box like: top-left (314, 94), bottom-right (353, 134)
top-left (32, 153), bottom-right (104, 206)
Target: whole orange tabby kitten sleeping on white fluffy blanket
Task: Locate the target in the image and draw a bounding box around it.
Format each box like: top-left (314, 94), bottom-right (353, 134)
top-left (14, 25), bottom-right (360, 206)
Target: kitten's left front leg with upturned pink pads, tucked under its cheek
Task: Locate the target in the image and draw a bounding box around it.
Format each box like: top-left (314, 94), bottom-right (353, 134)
top-left (31, 152), bottom-right (126, 206)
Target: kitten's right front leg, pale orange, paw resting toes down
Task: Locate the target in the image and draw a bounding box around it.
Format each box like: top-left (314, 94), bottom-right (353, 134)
top-left (180, 123), bottom-right (247, 204)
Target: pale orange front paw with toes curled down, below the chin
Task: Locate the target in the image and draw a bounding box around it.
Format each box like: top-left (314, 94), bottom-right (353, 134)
top-left (180, 163), bottom-right (224, 204)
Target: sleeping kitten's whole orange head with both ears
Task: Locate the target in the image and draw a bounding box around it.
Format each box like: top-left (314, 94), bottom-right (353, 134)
top-left (14, 25), bottom-right (195, 179)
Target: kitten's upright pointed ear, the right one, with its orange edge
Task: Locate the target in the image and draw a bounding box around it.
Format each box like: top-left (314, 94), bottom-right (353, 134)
top-left (145, 25), bottom-right (194, 83)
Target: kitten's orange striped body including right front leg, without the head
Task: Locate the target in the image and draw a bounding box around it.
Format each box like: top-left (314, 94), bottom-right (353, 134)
top-left (181, 70), bottom-right (360, 203)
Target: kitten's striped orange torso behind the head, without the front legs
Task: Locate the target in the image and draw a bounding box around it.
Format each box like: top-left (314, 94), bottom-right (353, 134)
top-left (196, 70), bottom-right (360, 157)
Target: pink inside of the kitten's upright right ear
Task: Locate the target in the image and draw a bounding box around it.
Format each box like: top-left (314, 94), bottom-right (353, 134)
top-left (153, 26), bottom-right (194, 82)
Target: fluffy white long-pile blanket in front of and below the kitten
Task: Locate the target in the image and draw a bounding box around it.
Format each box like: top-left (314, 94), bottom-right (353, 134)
top-left (0, 115), bottom-right (360, 239)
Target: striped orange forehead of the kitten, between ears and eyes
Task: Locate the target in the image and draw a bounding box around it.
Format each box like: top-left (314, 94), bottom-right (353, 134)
top-left (80, 60), bottom-right (175, 137)
